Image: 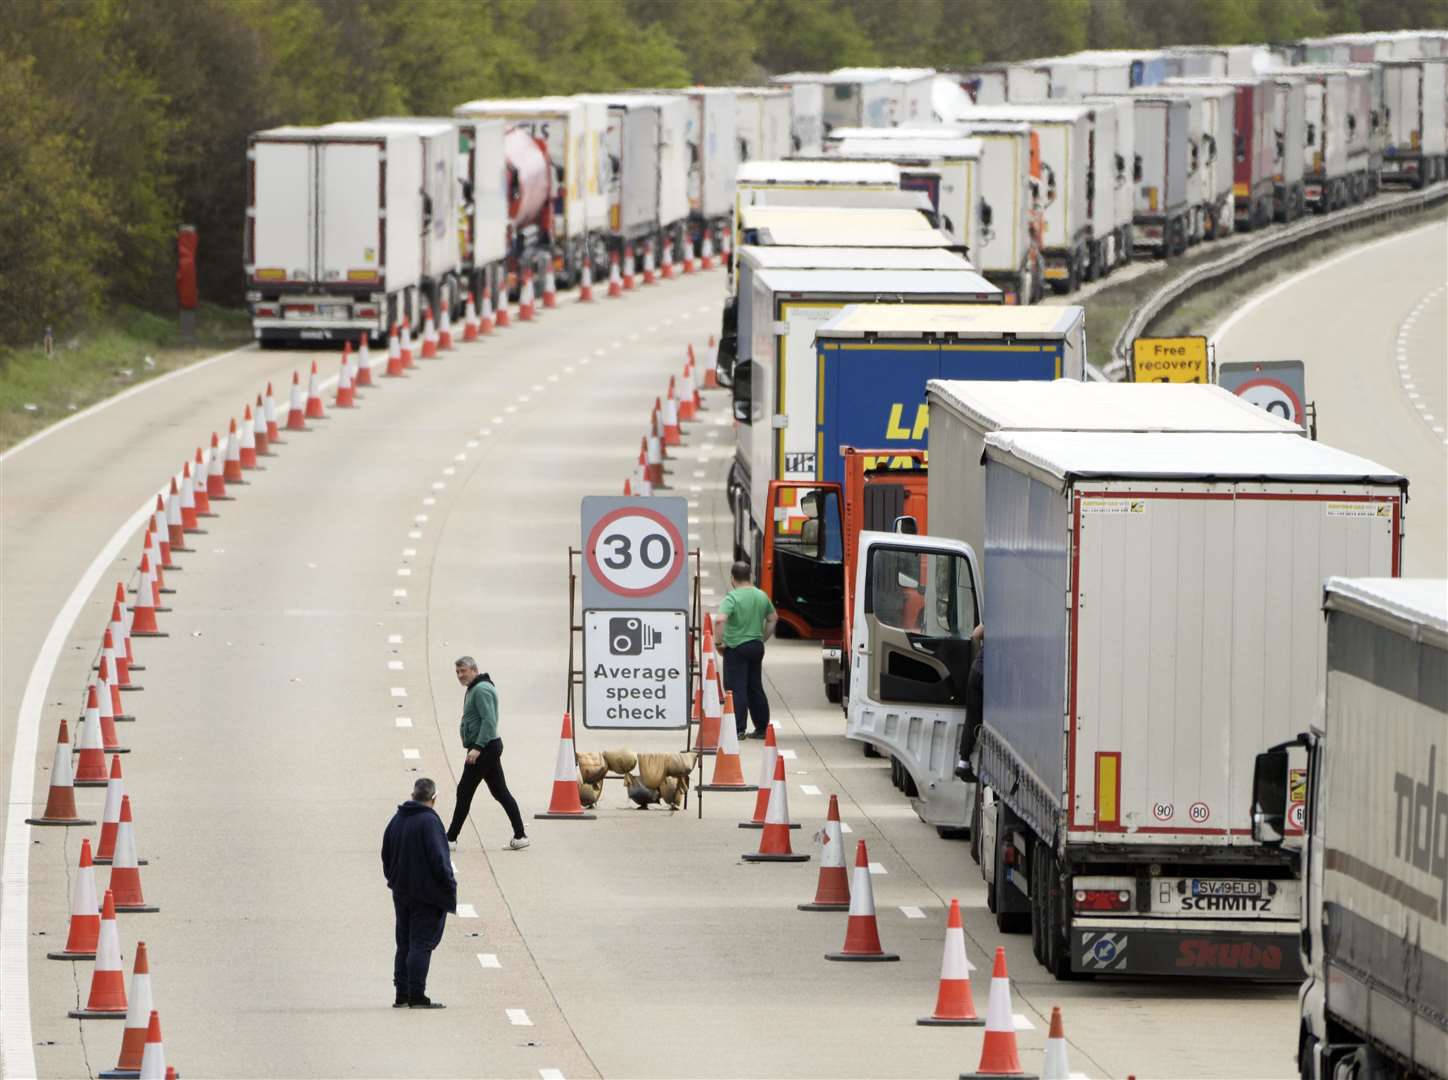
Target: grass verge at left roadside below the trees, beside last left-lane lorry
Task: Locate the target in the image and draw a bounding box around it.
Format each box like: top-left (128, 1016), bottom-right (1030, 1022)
top-left (0, 304), bottom-right (252, 450)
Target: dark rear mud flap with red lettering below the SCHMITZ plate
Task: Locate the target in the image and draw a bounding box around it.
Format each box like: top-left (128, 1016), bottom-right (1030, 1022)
top-left (1072, 927), bottom-right (1303, 983)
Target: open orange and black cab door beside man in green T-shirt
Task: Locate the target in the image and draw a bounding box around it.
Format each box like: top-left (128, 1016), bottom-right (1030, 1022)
top-left (759, 481), bottom-right (844, 638)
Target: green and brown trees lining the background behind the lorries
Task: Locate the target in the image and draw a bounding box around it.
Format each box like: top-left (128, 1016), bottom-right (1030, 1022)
top-left (0, 0), bottom-right (1448, 340)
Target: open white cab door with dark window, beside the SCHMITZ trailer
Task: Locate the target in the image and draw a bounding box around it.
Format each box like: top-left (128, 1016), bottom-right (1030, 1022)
top-left (846, 533), bottom-right (982, 828)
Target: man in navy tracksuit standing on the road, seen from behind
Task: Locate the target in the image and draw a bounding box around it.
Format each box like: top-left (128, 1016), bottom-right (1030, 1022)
top-left (382, 779), bottom-right (458, 1009)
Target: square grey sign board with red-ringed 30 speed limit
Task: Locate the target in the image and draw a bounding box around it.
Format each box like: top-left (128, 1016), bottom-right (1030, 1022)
top-left (582, 495), bottom-right (689, 611)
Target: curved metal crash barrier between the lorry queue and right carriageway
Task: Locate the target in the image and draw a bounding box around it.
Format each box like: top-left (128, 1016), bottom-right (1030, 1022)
top-left (1102, 184), bottom-right (1448, 382)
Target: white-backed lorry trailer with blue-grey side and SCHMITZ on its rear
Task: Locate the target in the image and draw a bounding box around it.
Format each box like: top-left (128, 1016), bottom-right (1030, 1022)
top-left (972, 431), bottom-right (1407, 982)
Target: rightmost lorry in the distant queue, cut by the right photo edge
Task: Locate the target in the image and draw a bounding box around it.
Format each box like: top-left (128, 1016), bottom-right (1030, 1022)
top-left (1381, 58), bottom-right (1448, 188)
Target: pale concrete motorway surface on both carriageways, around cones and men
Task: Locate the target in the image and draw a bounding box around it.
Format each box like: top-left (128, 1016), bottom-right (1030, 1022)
top-left (8, 214), bottom-right (1448, 1077)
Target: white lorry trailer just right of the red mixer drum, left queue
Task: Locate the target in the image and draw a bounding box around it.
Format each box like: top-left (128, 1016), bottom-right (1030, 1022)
top-left (453, 97), bottom-right (611, 282)
